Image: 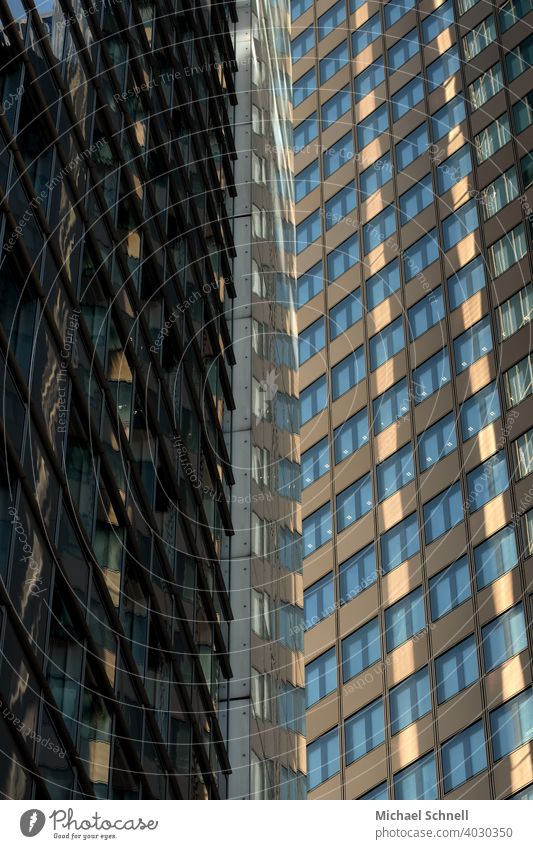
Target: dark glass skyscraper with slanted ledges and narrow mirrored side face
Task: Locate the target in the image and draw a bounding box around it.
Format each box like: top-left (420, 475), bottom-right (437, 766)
top-left (0, 0), bottom-right (305, 799)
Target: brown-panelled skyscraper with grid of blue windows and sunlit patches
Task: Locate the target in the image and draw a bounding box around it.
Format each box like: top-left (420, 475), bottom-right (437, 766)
top-left (292, 0), bottom-right (533, 799)
